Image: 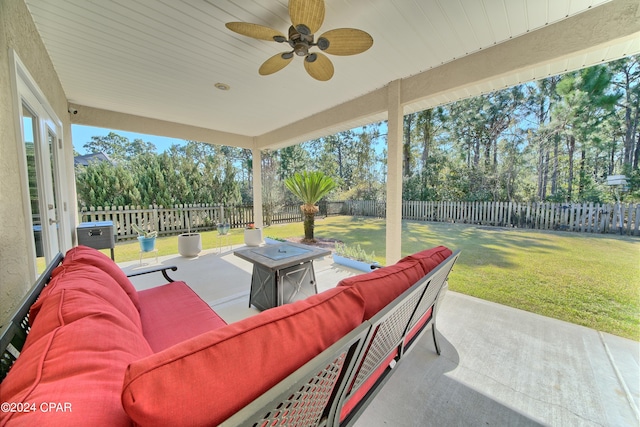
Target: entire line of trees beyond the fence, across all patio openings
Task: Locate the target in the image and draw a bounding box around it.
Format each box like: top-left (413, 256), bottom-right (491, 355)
top-left (76, 56), bottom-right (640, 210)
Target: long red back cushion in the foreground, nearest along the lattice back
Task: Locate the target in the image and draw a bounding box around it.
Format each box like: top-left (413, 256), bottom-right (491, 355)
top-left (122, 288), bottom-right (363, 425)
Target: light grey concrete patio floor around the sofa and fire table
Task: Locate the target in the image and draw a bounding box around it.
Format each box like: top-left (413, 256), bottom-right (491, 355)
top-left (120, 246), bottom-right (640, 427)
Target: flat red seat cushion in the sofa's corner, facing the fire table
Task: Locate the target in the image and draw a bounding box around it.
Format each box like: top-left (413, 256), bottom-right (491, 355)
top-left (139, 282), bottom-right (227, 353)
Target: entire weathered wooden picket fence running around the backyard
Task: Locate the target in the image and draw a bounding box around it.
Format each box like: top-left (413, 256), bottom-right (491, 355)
top-left (80, 200), bottom-right (640, 240)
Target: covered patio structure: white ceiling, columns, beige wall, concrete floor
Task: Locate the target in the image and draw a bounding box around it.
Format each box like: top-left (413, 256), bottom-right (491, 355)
top-left (0, 0), bottom-right (640, 426)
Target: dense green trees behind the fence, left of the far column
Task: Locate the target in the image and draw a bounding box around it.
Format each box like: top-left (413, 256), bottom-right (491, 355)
top-left (76, 132), bottom-right (242, 208)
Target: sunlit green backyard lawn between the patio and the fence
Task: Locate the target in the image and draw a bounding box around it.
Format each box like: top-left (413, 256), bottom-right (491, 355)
top-left (105, 216), bottom-right (640, 341)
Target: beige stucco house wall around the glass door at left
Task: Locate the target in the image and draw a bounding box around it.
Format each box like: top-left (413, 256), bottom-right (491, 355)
top-left (0, 0), bottom-right (75, 325)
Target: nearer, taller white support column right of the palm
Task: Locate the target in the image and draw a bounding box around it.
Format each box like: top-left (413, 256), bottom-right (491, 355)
top-left (386, 80), bottom-right (403, 265)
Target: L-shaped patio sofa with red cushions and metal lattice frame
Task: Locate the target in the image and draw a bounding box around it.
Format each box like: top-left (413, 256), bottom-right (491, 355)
top-left (0, 246), bottom-right (459, 426)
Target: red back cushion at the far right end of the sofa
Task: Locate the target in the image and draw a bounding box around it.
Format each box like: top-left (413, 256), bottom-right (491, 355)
top-left (338, 246), bottom-right (452, 320)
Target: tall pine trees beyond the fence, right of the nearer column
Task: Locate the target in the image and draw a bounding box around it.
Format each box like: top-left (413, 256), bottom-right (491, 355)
top-left (403, 56), bottom-right (640, 206)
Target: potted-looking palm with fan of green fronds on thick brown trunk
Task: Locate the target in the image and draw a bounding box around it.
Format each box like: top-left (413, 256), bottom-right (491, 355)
top-left (284, 171), bottom-right (336, 242)
